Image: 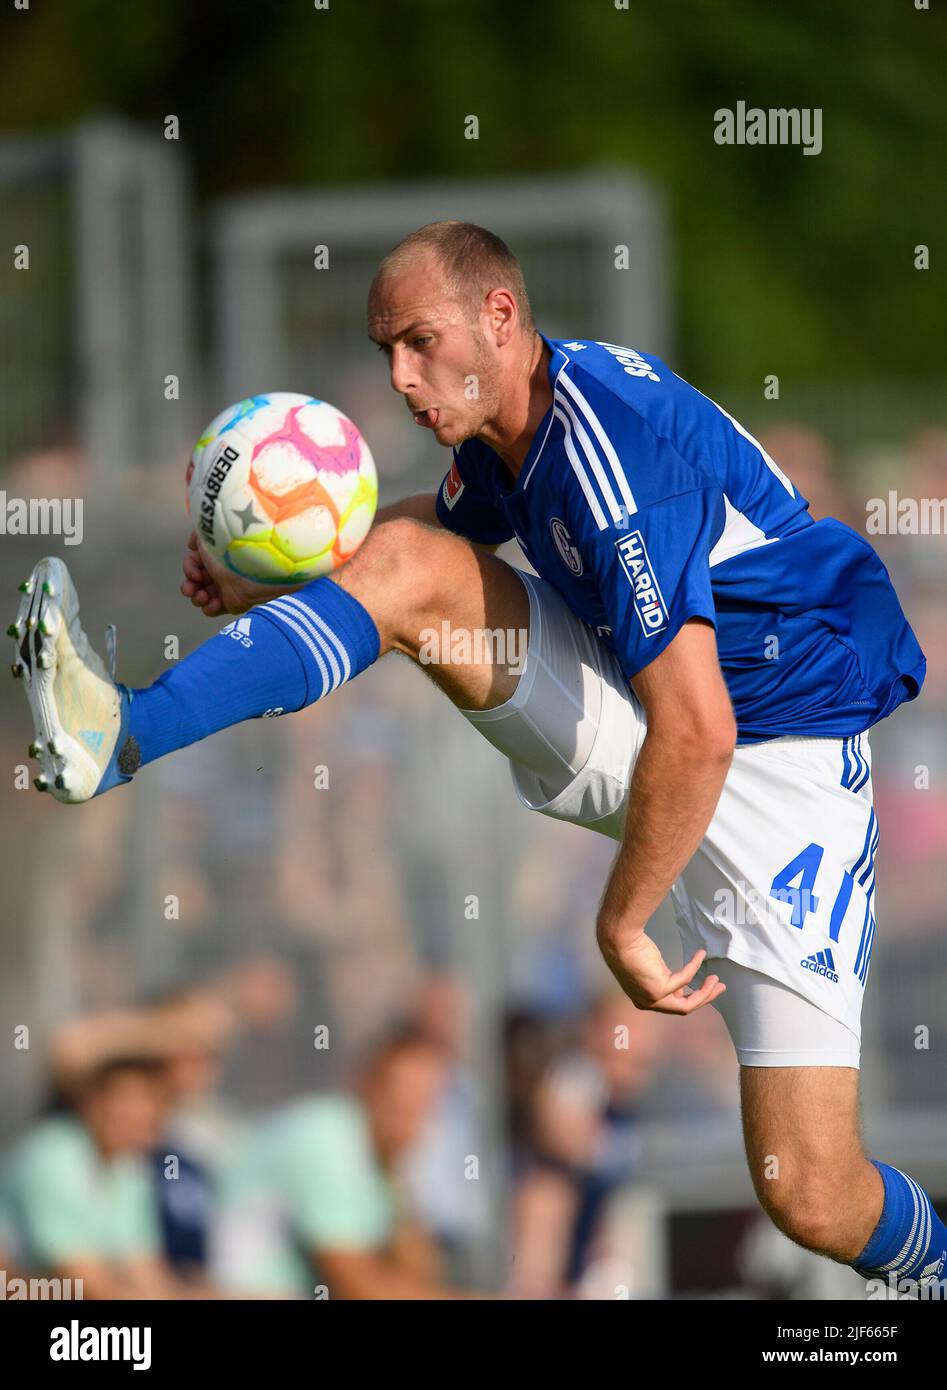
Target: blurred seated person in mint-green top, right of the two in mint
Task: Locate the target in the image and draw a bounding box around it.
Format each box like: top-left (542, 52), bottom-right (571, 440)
top-left (214, 1030), bottom-right (481, 1298)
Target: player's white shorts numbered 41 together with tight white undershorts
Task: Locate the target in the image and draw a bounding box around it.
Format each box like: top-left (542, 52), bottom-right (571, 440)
top-left (462, 571), bottom-right (879, 1068)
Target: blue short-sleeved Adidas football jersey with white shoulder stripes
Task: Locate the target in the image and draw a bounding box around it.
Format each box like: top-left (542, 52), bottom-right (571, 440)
top-left (437, 338), bottom-right (926, 744)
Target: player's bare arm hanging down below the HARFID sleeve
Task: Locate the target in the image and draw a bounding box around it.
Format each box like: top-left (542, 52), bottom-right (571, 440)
top-left (597, 619), bottom-right (737, 1013)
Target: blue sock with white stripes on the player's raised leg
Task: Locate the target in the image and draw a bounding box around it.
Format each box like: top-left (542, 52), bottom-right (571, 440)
top-left (99, 578), bottom-right (380, 791)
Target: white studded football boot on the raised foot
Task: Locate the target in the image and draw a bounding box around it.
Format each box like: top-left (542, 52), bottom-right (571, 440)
top-left (7, 556), bottom-right (140, 803)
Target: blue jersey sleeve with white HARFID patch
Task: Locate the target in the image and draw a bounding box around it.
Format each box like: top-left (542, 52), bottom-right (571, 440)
top-left (583, 488), bottom-right (723, 680)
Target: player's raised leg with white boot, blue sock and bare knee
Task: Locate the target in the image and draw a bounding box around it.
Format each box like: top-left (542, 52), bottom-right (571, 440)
top-left (11, 516), bottom-right (530, 802)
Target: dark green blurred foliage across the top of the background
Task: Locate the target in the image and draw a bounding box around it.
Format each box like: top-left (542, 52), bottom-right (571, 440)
top-left (0, 0), bottom-right (947, 385)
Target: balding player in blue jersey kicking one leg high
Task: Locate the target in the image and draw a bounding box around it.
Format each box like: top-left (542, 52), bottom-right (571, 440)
top-left (13, 222), bottom-right (947, 1282)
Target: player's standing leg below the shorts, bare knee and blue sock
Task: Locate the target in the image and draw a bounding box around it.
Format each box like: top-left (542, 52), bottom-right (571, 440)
top-left (740, 1066), bottom-right (947, 1286)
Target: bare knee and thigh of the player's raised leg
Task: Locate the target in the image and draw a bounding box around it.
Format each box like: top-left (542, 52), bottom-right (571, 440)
top-left (338, 517), bottom-right (530, 709)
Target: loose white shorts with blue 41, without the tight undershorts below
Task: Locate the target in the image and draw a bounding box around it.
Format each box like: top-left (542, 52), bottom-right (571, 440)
top-left (467, 574), bottom-right (877, 1037)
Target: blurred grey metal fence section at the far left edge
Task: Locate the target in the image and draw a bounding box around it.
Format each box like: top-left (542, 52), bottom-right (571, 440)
top-left (0, 121), bottom-right (191, 484)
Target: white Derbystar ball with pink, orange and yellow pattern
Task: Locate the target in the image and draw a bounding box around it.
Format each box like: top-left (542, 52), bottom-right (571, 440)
top-left (186, 391), bottom-right (378, 584)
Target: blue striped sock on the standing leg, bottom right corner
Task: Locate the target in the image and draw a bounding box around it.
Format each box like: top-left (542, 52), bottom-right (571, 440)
top-left (851, 1159), bottom-right (947, 1280)
